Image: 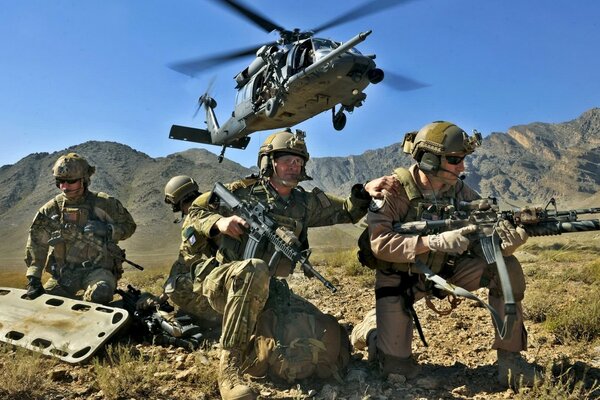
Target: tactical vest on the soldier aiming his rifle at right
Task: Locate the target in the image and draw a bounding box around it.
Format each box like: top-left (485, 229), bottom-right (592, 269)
top-left (357, 168), bottom-right (456, 273)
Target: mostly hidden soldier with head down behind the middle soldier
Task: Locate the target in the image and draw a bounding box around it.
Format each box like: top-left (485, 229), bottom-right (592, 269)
top-left (164, 175), bottom-right (221, 326)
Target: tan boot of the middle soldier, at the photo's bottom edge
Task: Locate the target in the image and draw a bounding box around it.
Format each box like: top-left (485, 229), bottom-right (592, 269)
top-left (219, 349), bottom-right (256, 400)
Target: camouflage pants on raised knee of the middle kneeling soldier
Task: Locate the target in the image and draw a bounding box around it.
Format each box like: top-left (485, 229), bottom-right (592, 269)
top-left (194, 258), bottom-right (270, 350)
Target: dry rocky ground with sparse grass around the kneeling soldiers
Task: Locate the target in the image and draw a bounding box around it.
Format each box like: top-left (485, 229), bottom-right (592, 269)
top-left (0, 238), bottom-right (600, 400)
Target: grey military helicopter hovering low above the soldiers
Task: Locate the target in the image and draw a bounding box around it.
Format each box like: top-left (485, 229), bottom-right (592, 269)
top-left (169, 0), bottom-right (426, 162)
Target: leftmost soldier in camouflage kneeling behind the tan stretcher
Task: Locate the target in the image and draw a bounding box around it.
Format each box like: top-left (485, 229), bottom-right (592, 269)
top-left (25, 153), bottom-right (136, 304)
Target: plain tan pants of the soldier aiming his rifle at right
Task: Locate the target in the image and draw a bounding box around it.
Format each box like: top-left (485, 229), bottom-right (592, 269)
top-left (351, 256), bottom-right (527, 358)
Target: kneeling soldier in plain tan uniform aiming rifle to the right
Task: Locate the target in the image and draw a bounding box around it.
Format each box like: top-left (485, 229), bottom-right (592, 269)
top-left (351, 121), bottom-right (536, 385)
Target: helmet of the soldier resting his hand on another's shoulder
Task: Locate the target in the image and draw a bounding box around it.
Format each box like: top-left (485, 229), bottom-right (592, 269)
top-left (257, 129), bottom-right (312, 181)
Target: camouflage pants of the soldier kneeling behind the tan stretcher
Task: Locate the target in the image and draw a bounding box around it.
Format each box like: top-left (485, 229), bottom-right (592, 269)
top-left (44, 266), bottom-right (117, 304)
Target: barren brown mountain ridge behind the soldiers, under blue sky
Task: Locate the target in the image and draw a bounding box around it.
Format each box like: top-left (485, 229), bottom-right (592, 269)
top-left (0, 108), bottom-right (600, 265)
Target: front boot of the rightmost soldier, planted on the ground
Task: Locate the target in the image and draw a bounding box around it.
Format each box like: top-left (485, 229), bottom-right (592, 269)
top-left (498, 349), bottom-right (543, 388)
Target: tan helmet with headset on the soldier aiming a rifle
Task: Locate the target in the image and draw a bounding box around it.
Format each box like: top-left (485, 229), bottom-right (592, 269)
top-left (403, 121), bottom-right (481, 172)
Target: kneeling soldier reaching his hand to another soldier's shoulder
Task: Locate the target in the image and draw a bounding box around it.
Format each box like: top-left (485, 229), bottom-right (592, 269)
top-left (183, 131), bottom-right (396, 400)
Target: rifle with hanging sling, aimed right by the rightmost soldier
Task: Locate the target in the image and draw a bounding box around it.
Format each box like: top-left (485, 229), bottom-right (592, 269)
top-left (393, 197), bottom-right (600, 341)
